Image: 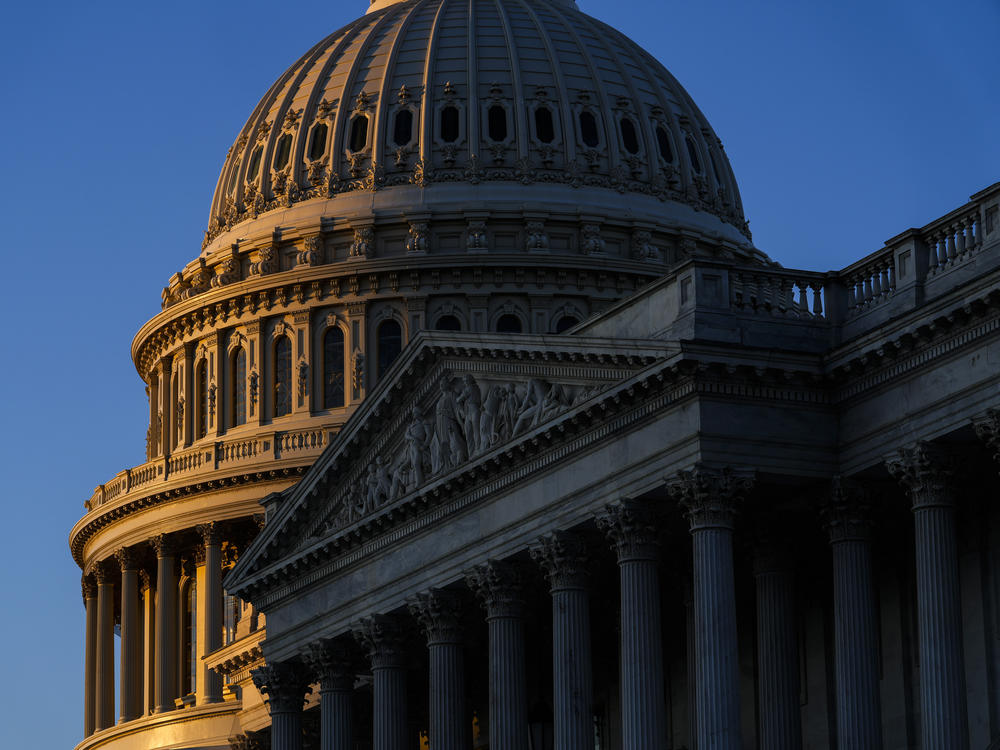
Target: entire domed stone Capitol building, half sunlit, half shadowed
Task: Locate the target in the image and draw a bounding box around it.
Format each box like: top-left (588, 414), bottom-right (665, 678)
top-left (70, 0), bottom-right (1000, 750)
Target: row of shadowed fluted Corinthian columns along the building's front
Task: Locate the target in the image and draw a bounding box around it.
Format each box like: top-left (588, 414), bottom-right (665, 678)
top-left (246, 444), bottom-right (980, 750)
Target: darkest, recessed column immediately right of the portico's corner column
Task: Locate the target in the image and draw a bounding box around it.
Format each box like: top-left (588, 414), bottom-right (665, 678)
top-left (753, 538), bottom-right (802, 750)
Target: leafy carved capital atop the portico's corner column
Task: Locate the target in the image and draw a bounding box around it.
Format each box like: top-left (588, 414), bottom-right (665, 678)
top-left (667, 463), bottom-right (755, 532)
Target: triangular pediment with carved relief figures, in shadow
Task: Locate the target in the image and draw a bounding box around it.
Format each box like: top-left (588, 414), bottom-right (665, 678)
top-left (227, 333), bottom-right (676, 600)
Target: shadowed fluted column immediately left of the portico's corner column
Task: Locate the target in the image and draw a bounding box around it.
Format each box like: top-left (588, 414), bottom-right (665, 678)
top-left (597, 500), bottom-right (667, 750)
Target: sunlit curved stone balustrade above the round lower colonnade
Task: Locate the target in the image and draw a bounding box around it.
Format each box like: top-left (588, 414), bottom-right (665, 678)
top-left (84, 425), bottom-right (338, 510)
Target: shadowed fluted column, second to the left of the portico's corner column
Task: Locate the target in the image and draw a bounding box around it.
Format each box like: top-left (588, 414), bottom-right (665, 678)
top-left (531, 532), bottom-right (594, 750)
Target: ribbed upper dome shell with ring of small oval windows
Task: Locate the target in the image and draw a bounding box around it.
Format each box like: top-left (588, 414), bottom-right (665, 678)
top-left (206, 0), bottom-right (749, 253)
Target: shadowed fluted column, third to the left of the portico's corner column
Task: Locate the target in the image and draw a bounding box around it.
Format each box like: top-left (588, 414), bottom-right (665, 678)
top-left (466, 561), bottom-right (528, 750)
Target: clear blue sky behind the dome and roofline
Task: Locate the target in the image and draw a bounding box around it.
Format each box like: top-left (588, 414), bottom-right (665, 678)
top-left (0, 0), bottom-right (1000, 748)
